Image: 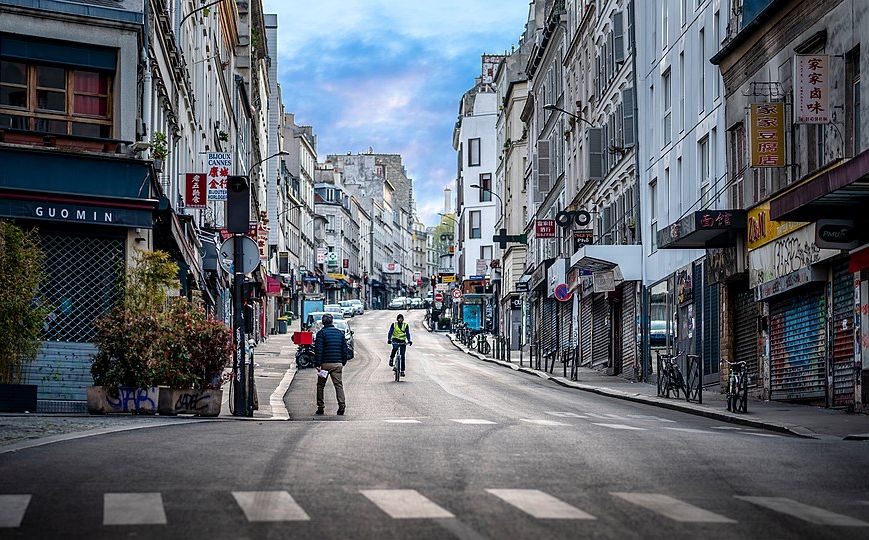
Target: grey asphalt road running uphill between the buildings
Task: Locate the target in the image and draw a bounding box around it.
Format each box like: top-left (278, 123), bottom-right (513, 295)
top-left (0, 312), bottom-right (869, 540)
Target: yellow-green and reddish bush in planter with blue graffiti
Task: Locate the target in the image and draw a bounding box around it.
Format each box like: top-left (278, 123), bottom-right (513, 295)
top-left (87, 251), bottom-right (178, 414)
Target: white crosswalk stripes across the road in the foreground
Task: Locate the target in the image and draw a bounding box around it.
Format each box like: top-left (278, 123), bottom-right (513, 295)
top-left (0, 487), bottom-right (869, 529)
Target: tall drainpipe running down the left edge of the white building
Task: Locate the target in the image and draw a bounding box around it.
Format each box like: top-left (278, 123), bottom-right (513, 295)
top-left (629, 0), bottom-right (655, 380)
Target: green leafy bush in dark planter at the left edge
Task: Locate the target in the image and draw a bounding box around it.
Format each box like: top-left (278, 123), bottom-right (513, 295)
top-left (0, 221), bottom-right (51, 412)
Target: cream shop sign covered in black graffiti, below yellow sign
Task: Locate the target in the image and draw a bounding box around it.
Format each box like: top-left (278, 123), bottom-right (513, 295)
top-left (748, 223), bottom-right (839, 288)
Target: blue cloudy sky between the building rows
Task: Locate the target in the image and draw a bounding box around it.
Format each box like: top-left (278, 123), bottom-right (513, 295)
top-left (264, 0), bottom-right (528, 224)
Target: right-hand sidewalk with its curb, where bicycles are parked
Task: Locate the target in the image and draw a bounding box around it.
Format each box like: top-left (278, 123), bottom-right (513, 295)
top-left (447, 334), bottom-right (869, 440)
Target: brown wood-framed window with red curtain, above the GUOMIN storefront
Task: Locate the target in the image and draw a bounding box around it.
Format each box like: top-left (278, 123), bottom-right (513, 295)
top-left (0, 60), bottom-right (112, 138)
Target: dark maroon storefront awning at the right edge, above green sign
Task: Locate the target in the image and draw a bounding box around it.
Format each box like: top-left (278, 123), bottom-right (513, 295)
top-left (770, 150), bottom-right (869, 221)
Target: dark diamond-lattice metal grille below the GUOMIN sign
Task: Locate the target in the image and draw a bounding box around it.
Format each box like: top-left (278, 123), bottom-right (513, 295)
top-left (41, 233), bottom-right (124, 343)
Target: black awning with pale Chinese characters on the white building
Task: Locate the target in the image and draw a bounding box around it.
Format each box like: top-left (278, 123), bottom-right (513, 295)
top-left (657, 210), bottom-right (746, 249)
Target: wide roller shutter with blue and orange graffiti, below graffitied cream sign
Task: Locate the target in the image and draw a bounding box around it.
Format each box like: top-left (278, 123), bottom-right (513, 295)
top-left (769, 287), bottom-right (827, 400)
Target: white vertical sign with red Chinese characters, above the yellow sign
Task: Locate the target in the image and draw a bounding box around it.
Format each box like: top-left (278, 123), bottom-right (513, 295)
top-left (794, 54), bottom-right (830, 124)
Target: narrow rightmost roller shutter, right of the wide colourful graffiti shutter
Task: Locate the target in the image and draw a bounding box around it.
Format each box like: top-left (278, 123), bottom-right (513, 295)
top-left (832, 261), bottom-right (854, 407)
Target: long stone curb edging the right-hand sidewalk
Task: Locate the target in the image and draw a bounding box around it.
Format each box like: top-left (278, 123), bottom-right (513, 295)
top-left (447, 334), bottom-right (816, 440)
